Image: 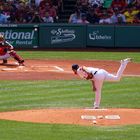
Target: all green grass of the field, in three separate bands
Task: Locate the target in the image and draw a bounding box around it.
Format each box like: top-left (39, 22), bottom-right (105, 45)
top-left (0, 51), bottom-right (140, 140)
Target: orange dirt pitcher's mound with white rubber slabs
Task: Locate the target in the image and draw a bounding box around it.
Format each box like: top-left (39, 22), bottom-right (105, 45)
top-left (0, 108), bottom-right (140, 126)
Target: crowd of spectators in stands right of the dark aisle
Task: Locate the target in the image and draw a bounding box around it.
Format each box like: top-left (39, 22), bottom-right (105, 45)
top-left (68, 0), bottom-right (140, 24)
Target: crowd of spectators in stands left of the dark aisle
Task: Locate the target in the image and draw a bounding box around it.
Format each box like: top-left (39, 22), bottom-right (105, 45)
top-left (0, 0), bottom-right (61, 24)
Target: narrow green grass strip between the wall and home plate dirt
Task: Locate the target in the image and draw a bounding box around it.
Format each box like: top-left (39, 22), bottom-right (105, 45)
top-left (19, 51), bottom-right (140, 62)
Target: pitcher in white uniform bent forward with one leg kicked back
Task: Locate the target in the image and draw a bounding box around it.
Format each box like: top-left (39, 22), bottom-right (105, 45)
top-left (72, 58), bottom-right (131, 109)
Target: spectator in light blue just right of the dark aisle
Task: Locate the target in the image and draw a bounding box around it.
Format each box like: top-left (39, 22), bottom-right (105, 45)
top-left (68, 9), bottom-right (82, 23)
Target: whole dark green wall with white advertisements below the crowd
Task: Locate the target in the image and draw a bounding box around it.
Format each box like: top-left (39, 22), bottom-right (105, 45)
top-left (0, 24), bottom-right (140, 49)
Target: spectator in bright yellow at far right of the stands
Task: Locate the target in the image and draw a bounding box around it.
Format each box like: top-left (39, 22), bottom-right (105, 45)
top-left (124, 5), bottom-right (139, 23)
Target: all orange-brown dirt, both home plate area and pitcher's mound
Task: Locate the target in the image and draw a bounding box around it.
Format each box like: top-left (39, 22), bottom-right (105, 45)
top-left (0, 60), bottom-right (140, 126)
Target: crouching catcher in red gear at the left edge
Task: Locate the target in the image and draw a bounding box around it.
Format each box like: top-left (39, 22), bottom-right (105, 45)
top-left (0, 34), bottom-right (24, 66)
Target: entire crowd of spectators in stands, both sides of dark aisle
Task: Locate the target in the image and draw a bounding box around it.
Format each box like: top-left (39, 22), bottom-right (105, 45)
top-left (0, 0), bottom-right (140, 24)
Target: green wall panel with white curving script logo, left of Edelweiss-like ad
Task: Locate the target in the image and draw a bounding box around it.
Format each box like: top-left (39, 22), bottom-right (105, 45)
top-left (39, 24), bottom-right (86, 48)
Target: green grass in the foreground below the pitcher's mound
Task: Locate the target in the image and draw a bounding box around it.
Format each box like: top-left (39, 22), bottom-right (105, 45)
top-left (0, 121), bottom-right (140, 140)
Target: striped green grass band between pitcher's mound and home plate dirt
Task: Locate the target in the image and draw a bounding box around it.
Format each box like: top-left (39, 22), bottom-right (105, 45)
top-left (0, 77), bottom-right (140, 111)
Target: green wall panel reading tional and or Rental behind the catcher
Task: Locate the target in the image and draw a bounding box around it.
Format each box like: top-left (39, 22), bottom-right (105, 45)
top-left (0, 24), bottom-right (39, 48)
